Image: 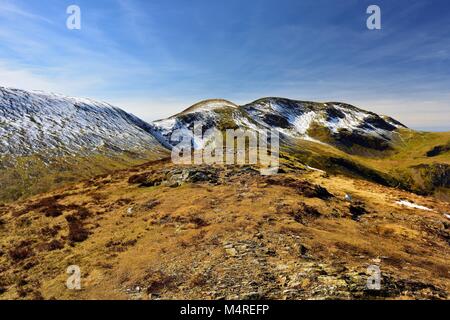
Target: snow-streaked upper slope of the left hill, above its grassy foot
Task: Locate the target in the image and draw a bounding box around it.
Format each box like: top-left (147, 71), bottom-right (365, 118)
top-left (0, 87), bottom-right (169, 156)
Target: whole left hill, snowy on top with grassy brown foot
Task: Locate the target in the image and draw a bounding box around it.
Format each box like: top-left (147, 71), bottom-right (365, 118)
top-left (0, 87), bottom-right (167, 201)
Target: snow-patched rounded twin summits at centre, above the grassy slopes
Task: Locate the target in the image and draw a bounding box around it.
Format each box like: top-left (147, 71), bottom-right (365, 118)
top-left (154, 98), bottom-right (405, 150)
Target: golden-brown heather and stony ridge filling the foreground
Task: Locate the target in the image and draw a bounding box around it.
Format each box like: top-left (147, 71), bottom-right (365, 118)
top-left (0, 160), bottom-right (450, 299)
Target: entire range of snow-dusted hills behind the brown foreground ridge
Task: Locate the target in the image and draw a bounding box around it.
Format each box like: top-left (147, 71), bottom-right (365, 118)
top-left (0, 88), bottom-right (450, 201)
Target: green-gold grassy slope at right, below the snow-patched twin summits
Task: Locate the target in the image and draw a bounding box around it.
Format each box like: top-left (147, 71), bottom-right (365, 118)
top-left (283, 129), bottom-right (450, 201)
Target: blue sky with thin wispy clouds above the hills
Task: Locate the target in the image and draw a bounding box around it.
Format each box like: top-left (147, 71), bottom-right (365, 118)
top-left (0, 0), bottom-right (450, 130)
